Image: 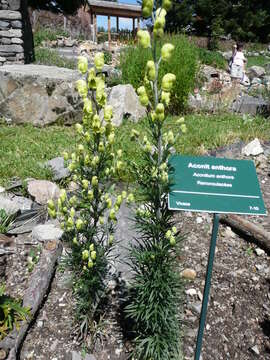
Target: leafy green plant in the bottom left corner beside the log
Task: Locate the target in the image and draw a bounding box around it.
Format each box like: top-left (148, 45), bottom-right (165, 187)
top-left (0, 285), bottom-right (30, 340)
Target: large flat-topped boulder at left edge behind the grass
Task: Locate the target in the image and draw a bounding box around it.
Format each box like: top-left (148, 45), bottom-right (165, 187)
top-left (0, 64), bottom-right (81, 126)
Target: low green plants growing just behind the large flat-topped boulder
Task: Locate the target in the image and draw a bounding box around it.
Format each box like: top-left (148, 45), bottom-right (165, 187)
top-left (35, 48), bottom-right (76, 69)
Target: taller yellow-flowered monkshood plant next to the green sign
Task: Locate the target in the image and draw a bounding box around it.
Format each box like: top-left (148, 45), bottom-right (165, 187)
top-left (126, 0), bottom-right (186, 360)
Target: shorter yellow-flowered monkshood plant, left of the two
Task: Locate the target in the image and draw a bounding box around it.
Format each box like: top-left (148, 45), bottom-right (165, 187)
top-left (48, 53), bottom-right (133, 335)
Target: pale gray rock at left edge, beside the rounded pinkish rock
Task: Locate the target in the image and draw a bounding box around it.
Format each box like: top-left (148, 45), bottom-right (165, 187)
top-left (0, 193), bottom-right (33, 215)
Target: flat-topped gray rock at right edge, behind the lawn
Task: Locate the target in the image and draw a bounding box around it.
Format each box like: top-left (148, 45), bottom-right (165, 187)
top-left (232, 95), bottom-right (270, 115)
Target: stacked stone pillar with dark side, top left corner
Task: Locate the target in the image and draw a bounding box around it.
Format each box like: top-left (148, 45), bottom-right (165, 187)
top-left (0, 0), bottom-right (34, 65)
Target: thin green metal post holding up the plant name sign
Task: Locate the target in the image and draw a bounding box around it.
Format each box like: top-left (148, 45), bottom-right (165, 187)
top-left (194, 214), bottom-right (219, 360)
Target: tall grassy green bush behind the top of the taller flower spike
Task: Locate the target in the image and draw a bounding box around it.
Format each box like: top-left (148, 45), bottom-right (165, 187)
top-left (120, 35), bottom-right (197, 113)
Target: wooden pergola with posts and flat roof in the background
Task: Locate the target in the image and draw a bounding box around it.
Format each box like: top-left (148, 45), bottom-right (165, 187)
top-left (88, 0), bottom-right (142, 42)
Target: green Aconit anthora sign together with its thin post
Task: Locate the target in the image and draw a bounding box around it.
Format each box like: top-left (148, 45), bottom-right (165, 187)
top-left (168, 155), bottom-right (267, 360)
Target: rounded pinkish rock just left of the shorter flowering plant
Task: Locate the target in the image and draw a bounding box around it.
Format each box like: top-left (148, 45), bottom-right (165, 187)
top-left (27, 180), bottom-right (60, 205)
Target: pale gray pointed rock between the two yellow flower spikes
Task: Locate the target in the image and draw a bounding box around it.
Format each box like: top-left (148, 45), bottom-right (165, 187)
top-left (105, 85), bottom-right (146, 126)
